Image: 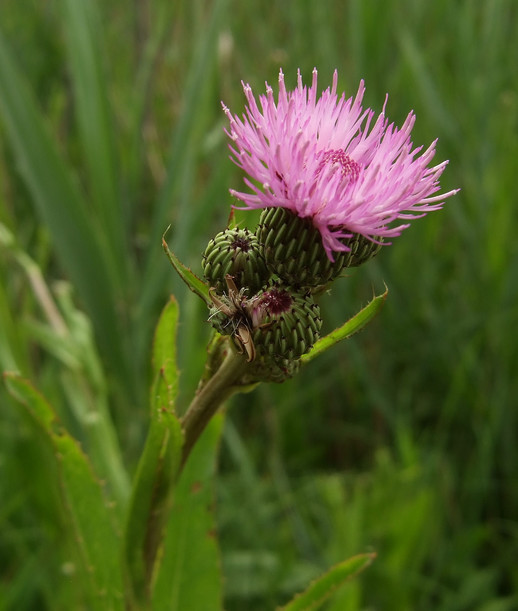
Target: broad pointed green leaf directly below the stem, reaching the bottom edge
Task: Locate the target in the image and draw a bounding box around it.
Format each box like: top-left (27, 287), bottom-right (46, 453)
top-left (152, 413), bottom-right (223, 611)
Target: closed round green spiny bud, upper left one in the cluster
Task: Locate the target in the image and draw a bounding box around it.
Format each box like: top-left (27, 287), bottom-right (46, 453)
top-left (202, 228), bottom-right (270, 295)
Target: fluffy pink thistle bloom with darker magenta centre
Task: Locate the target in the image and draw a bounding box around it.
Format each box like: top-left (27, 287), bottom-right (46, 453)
top-left (223, 69), bottom-right (458, 261)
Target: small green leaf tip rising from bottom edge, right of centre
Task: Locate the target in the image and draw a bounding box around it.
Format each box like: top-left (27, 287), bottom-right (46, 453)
top-left (278, 553), bottom-right (376, 611)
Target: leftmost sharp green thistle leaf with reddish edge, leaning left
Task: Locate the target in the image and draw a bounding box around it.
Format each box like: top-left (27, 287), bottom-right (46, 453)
top-left (4, 373), bottom-right (124, 611)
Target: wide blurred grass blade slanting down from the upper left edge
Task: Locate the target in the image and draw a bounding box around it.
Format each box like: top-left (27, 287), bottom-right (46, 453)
top-left (0, 28), bottom-right (129, 382)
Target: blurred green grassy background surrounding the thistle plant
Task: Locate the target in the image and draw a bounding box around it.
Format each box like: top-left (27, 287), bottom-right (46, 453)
top-left (0, 0), bottom-right (518, 611)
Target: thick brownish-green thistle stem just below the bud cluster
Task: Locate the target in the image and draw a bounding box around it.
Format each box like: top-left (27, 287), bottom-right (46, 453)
top-left (182, 349), bottom-right (248, 466)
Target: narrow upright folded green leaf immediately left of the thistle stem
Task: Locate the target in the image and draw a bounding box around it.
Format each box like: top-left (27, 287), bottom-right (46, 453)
top-left (124, 298), bottom-right (183, 603)
